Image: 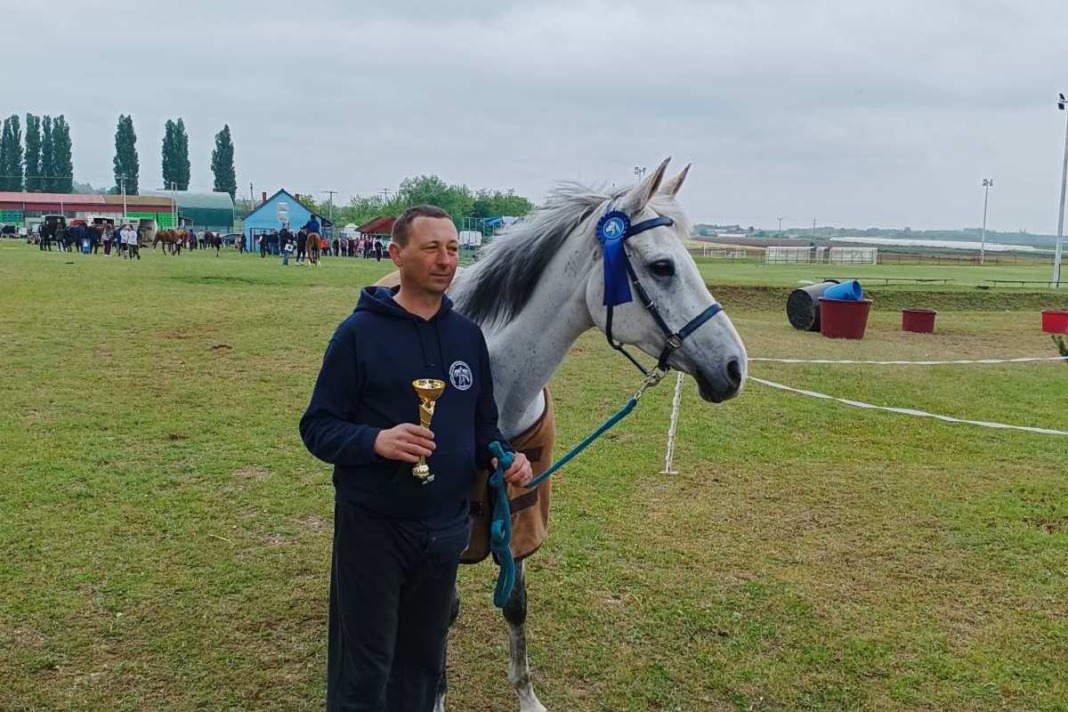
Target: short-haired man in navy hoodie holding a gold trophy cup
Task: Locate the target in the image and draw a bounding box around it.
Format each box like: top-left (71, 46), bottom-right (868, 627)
top-left (300, 205), bottom-right (533, 712)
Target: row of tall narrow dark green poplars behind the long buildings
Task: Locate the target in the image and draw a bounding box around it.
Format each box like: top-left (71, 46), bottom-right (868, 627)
top-left (0, 113), bottom-right (237, 197)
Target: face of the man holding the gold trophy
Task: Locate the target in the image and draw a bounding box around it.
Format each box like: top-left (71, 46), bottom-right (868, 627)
top-left (390, 218), bottom-right (460, 296)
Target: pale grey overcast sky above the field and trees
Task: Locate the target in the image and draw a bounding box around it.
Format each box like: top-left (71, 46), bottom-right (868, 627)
top-left (8, 0), bottom-right (1068, 233)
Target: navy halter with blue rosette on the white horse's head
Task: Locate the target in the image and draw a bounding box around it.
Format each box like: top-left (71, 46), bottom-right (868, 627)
top-left (597, 208), bottom-right (723, 378)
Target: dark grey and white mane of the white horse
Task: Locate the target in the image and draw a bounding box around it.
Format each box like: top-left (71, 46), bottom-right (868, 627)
top-left (450, 183), bottom-right (689, 326)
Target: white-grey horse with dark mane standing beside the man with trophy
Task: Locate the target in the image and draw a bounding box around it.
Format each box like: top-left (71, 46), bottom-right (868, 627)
top-left (435, 160), bottom-right (747, 712)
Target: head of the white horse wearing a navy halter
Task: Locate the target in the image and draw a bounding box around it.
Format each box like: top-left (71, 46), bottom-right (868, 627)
top-left (580, 160), bottom-right (747, 402)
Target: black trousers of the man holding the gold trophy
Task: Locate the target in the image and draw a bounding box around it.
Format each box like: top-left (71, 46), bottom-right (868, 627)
top-left (327, 503), bottom-right (470, 712)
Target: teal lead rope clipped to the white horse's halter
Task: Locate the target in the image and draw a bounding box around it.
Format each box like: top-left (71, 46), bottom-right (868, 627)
top-left (489, 370), bottom-right (668, 608)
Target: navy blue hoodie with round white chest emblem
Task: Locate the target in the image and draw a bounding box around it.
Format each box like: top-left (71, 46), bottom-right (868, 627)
top-left (300, 287), bottom-right (509, 528)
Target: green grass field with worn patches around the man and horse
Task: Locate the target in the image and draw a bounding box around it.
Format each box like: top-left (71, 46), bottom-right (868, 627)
top-left (0, 242), bottom-right (1068, 712)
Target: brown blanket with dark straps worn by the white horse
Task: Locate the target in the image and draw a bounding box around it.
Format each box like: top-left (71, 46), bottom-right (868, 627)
top-left (375, 272), bottom-right (556, 564)
